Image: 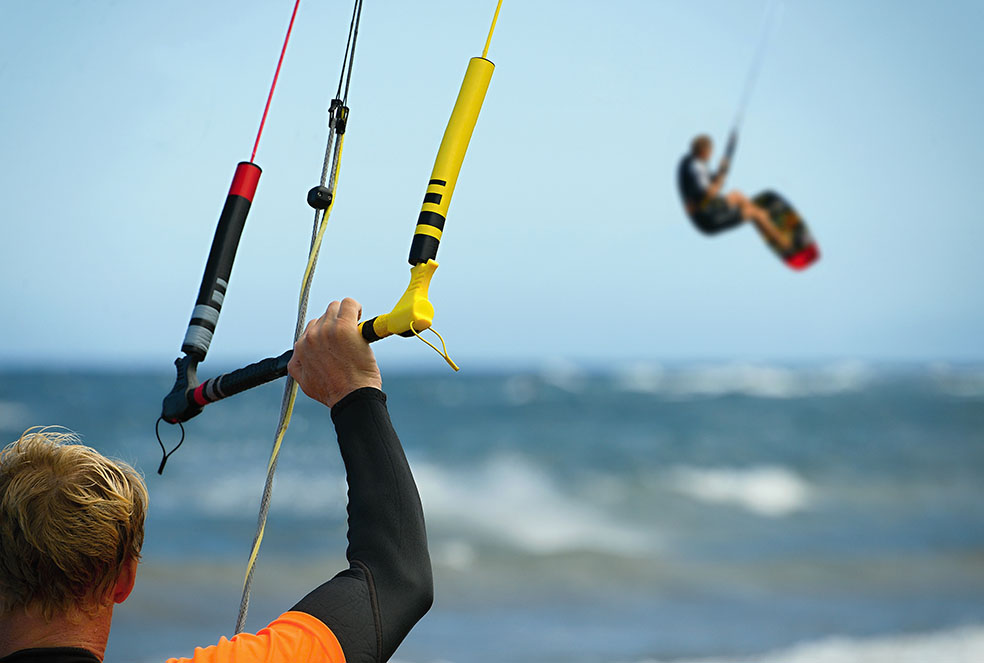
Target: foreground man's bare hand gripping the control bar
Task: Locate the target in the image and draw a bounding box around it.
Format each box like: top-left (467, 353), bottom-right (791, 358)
top-left (287, 298), bottom-right (383, 407)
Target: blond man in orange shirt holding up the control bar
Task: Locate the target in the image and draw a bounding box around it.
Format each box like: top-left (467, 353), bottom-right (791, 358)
top-left (0, 299), bottom-right (433, 663)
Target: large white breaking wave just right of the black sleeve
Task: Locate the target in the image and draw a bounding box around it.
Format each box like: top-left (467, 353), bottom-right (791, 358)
top-left (414, 456), bottom-right (655, 565)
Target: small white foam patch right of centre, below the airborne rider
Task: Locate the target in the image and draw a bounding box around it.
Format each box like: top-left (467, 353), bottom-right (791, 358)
top-left (668, 465), bottom-right (815, 518)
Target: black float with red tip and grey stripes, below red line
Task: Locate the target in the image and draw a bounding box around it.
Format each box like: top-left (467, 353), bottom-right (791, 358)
top-left (181, 161), bottom-right (262, 361)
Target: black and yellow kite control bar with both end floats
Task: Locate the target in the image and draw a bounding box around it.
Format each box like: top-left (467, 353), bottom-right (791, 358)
top-left (161, 57), bottom-right (495, 424)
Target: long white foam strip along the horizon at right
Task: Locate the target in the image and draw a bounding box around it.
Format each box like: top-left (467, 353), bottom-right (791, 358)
top-left (616, 362), bottom-right (872, 398)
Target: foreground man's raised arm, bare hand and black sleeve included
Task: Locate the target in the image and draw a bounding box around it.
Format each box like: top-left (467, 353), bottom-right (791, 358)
top-left (289, 299), bottom-right (433, 663)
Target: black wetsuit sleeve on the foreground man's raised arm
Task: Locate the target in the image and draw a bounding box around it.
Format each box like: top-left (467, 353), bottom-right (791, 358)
top-left (293, 388), bottom-right (434, 663)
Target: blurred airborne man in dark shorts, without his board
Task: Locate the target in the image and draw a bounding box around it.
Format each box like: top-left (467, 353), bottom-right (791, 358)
top-left (677, 134), bottom-right (791, 250)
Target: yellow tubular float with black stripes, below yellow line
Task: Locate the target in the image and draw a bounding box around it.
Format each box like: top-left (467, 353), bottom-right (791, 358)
top-left (410, 58), bottom-right (495, 264)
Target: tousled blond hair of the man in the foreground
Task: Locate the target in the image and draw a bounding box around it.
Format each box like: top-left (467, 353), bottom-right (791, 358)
top-left (0, 428), bottom-right (147, 619)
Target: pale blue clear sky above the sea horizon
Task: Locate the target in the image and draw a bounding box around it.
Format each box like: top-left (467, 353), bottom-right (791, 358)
top-left (0, 0), bottom-right (984, 368)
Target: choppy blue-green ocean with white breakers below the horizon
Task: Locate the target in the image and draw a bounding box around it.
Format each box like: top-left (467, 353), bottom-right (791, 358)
top-left (0, 362), bottom-right (984, 663)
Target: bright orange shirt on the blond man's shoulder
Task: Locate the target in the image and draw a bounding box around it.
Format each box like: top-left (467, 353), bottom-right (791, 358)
top-left (167, 611), bottom-right (345, 663)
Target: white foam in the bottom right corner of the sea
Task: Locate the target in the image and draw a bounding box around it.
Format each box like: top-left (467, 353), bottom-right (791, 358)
top-left (639, 626), bottom-right (984, 663)
